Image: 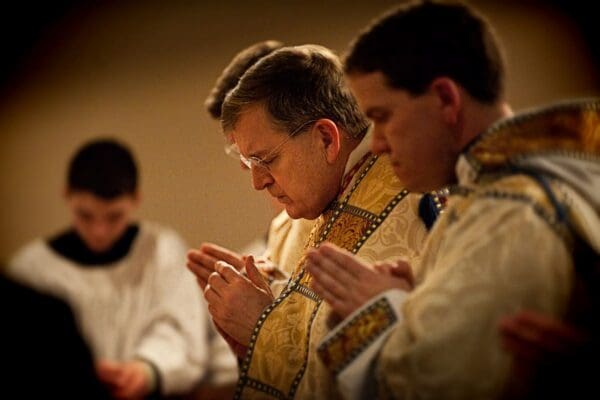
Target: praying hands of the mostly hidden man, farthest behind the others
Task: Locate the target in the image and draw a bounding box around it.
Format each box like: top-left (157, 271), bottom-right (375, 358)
top-left (187, 243), bottom-right (244, 290)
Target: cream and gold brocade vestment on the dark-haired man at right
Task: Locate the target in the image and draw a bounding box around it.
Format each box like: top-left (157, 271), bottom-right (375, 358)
top-left (326, 97), bottom-right (600, 399)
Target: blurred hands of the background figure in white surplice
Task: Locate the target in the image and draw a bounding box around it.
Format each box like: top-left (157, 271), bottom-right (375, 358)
top-left (96, 360), bottom-right (150, 400)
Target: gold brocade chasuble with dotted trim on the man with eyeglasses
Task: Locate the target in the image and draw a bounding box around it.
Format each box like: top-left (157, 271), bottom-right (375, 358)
top-left (236, 155), bottom-right (426, 399)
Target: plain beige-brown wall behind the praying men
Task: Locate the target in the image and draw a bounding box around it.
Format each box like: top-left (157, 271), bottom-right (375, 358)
top-left (0, 0), bottom-right (599, 260)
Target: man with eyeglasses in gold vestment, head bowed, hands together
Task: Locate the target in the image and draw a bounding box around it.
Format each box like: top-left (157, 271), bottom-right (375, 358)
top-left (190, 45), bottom-right (426, 399)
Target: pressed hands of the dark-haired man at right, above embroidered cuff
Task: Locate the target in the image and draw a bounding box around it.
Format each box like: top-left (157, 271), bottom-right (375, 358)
top-left (306, 243), bottom-right (414, 319)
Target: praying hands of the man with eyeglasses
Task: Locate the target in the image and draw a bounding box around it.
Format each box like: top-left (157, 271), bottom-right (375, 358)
top-left (204, 256), bottom-right (274, 356)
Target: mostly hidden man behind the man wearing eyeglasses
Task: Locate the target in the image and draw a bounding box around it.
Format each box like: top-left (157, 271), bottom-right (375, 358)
top-left (188, 40), bottom-right (314, 398)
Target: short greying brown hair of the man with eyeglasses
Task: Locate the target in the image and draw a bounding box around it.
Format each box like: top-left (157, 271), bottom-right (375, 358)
top-left (221, 45), bottom-right (369, 138)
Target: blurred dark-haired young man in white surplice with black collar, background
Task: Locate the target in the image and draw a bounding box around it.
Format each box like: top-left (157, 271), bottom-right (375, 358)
top-left (7, 139), bottom-right (209, 399)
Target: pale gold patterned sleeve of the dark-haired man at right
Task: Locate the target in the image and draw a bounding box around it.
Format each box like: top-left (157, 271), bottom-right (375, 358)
top-left (318, 199), bottom-right (573, 399)
